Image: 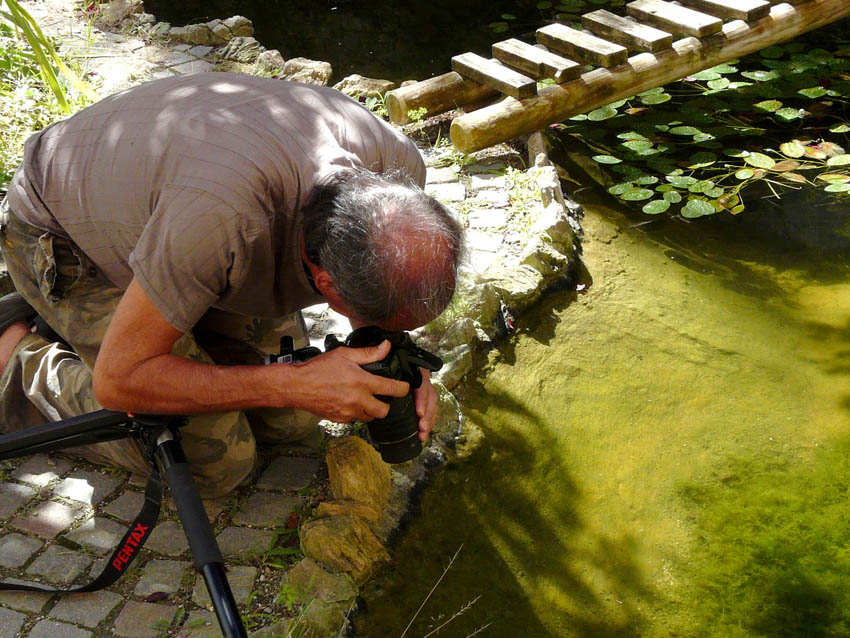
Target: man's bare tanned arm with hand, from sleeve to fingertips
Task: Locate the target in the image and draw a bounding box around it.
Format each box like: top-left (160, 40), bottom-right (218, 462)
top-left (94, 279), bottom-right (408, 422)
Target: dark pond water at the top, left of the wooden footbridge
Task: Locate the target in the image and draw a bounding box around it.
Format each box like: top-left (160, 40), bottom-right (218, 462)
top-left (144, 0), bottom-right (539, 82)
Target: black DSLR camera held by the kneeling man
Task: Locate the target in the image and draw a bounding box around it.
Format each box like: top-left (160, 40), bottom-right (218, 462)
top-left (268, 326), bottom-right (443, 463)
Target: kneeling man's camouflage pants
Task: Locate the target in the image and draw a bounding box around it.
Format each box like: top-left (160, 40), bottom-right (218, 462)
top-left (0, 202), bottom-right (319, 497)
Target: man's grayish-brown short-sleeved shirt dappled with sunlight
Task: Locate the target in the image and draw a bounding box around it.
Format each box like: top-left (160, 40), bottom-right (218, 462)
top-left (8, 73), bottom-right (425, 332)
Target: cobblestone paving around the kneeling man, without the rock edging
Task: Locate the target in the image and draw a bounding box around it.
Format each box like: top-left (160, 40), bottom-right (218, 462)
top-left (0, 0), bottom-right (524, 638)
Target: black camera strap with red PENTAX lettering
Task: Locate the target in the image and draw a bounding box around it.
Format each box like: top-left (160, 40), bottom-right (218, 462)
top-left (0, 461), bottom-right (162, 594)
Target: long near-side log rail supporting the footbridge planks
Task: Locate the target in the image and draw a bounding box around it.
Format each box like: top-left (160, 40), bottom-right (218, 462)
top-left (451, 0), bottom-right (850, 153)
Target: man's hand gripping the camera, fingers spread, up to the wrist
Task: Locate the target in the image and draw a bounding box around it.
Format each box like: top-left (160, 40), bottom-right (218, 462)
top-left (284, 341), bottom-right (410, 430)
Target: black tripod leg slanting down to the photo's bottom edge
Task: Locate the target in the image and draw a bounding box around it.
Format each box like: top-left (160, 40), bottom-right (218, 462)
top-left (156, 430), bottom-right (248, 638)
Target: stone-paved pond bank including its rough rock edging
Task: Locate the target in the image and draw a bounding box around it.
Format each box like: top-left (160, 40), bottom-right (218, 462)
top-left (0, 0), bottom-right (579, 638)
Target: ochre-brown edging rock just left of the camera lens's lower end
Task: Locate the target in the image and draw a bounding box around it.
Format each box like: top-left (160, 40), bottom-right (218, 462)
top-left (325, 436), bottom-right (391, 512)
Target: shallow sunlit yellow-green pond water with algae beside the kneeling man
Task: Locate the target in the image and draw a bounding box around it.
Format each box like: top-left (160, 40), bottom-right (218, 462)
top-left (355, 199), bottom-right (850, 638)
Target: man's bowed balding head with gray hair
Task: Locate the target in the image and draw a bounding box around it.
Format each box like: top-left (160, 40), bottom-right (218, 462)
top-left (303, 169), bottom-right (463, 325)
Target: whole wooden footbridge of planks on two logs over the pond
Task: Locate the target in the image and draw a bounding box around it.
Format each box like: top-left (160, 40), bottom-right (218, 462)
top-left (387, 0), bottom-right (850, 153)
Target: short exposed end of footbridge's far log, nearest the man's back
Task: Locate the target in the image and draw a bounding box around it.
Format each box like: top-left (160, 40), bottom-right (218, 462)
top-left (386, 71), bottom-right (499, 125)
